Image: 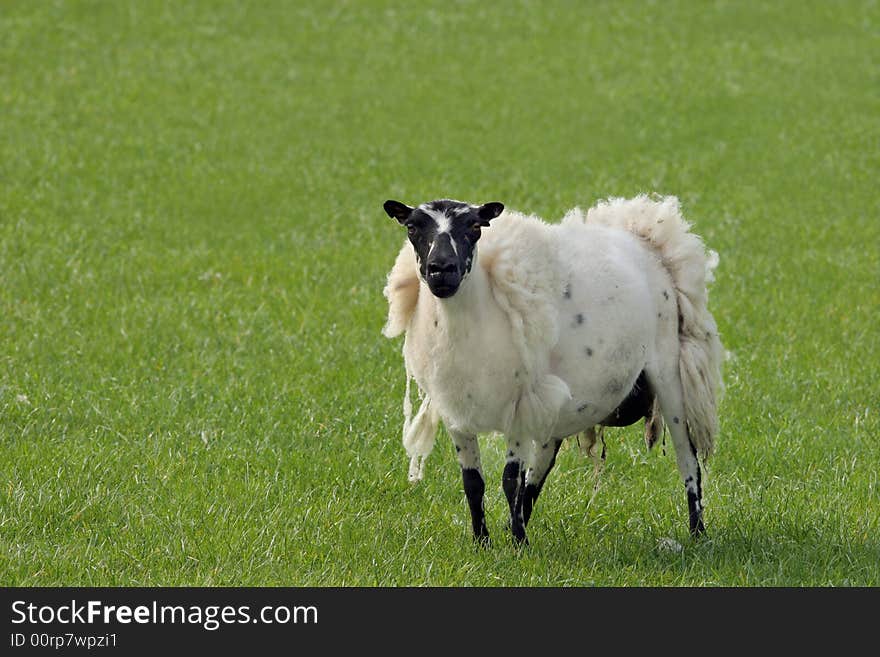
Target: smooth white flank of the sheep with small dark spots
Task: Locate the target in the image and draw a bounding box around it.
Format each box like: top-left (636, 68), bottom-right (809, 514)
top-left (550, 222), bottom-right (678, 438)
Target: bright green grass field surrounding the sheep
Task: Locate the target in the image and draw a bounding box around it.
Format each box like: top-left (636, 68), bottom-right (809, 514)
top-left (0, 0), bottom-right (880, 586)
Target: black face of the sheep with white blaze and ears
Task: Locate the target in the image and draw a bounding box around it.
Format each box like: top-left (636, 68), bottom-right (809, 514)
top-left (384, 199), bottom-right (504, 299)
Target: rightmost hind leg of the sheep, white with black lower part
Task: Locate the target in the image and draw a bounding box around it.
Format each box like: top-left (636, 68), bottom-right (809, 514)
top-left (652, 371), bottom-right (706, 536)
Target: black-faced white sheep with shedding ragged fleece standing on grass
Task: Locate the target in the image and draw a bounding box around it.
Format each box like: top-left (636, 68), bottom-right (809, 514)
top-left (383, 195), bottom-right (723, 544)
